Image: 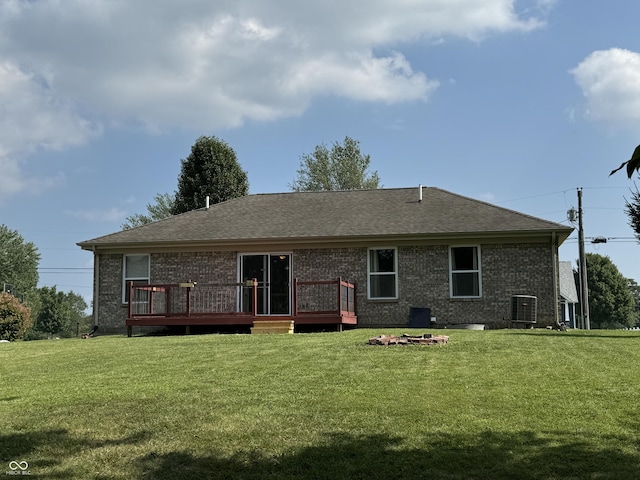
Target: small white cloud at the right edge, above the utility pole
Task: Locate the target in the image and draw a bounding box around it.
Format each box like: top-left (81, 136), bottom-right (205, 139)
top-left (571, 48), bottom-right (640, 131)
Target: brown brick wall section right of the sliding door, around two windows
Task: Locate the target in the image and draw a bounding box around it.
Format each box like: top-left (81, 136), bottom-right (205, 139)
top-left (294, 244), bottom-right (555, 327)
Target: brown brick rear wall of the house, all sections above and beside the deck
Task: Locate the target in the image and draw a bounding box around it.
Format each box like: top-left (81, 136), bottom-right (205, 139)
top-left (97, 244), bottom-right (557, 330)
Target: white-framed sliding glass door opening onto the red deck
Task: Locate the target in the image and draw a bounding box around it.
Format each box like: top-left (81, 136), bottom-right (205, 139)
top-left (240, 254), bottom-right (291, 315)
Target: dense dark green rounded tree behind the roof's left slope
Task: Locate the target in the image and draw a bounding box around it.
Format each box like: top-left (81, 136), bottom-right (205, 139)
top-left (172, 136), bottom-right (249, 215)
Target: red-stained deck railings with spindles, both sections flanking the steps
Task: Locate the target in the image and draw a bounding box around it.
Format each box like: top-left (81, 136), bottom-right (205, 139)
top-left (128, 278), bottom-right (356, 323)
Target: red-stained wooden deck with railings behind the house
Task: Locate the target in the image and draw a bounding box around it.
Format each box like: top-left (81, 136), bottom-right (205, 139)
top-left (126, 278), bottom-right (358, 336)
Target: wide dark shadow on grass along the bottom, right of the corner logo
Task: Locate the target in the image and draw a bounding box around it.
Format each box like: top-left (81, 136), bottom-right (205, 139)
top-left (139, 431), bottom-right (640, 480)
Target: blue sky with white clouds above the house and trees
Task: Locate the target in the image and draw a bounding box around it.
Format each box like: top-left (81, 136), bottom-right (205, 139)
top-left (0, 0), bottom-right (640, 301)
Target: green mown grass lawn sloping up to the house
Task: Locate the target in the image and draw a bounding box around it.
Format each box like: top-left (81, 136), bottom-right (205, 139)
top-left (0, 330), bottom-right (640, 480)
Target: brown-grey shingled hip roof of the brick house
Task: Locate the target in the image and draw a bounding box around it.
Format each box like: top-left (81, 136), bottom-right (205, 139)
top-left (78, 187), bottom-right (573, 250)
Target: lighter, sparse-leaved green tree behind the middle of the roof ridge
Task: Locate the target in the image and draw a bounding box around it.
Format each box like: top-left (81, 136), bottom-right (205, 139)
top-left (289, 137), bottom-right (381, 192)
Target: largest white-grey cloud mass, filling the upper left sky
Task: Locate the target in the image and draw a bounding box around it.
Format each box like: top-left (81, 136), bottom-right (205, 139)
top-left (0, 0), bottom-right (550, 201)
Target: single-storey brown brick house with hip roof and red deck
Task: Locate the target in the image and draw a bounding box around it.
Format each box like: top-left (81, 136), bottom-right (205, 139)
top-left (78, 186), bottom-right (572, 334)
